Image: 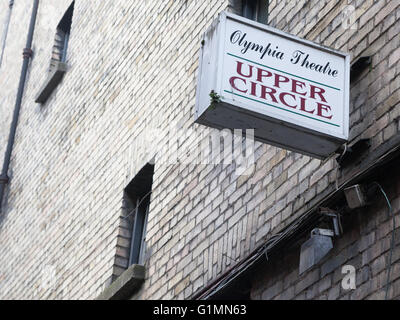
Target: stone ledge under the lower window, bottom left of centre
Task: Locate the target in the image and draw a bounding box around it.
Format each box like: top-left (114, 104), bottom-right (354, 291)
top-left (96, 264), bottom-right (145, 300)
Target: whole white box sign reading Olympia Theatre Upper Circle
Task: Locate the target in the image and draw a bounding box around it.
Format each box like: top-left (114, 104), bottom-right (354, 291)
top-left (196, 12), bottom-right (350, 158)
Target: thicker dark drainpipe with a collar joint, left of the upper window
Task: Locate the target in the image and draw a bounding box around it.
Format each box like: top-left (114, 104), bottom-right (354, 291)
top-left (0, 0), bottom-right (39, 213)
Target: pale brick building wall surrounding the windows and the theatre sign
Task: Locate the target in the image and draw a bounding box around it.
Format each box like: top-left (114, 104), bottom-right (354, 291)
top-left (0, 0), bottom-right (400, 299)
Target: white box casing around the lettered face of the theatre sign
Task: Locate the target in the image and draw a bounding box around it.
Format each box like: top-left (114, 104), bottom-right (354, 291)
top-left (195, 12), bottom-right (350, 159)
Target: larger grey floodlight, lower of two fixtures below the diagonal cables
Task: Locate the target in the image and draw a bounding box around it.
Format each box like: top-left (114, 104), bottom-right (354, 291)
top-left (299, 228), bottom-right (334, 274)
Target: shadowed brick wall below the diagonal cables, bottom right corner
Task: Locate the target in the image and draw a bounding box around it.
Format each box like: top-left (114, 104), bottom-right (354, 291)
top-left (251, 172), bottom-right (400, 300)
